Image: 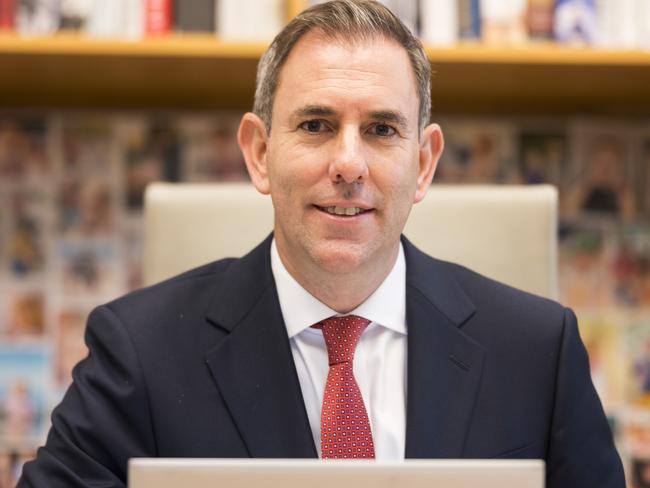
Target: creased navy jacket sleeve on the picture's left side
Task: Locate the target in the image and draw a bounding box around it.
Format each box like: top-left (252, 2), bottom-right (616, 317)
top-left (18, 306), bottom-right (156, 488)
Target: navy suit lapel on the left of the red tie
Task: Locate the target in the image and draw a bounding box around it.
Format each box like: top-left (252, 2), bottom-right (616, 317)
top-left (206, 237), bottom-right (317, 458)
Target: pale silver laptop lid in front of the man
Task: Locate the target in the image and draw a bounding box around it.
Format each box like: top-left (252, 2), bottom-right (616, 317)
top-left (128, 458), bottom-right (545, 488)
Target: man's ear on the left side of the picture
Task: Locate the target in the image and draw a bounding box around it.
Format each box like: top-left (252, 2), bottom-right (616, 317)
top-left (237, 112), bottom-right (270, 195)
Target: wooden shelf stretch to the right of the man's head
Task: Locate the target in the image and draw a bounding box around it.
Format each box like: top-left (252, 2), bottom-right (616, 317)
top-left (427, 45), bottom-right (650, 117)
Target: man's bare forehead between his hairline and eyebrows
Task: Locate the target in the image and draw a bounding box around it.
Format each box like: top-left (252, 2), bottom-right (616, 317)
top-left (274, 30), bottom-right (418, 117)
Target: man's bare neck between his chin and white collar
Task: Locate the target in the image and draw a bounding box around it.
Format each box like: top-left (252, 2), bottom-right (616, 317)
top-left (276, 240), bottom-right (399, 313)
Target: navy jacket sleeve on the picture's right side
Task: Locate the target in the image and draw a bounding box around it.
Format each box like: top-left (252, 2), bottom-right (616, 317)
top-left (546, 309), bottom-right (625, 488)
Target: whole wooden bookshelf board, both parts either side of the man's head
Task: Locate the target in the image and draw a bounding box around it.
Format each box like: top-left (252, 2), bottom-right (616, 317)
top-left (0, 35), bottom-right (650, 117)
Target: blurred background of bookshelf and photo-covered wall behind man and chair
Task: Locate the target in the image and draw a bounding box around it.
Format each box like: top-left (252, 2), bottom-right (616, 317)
top-left (0, 0), bottom-right (650, 487)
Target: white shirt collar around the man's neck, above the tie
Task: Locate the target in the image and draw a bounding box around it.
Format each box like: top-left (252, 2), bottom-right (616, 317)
top-left (271, 239), bottom-right (406, 338)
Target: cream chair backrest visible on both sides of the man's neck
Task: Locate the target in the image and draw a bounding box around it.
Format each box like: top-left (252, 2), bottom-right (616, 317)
top-left (144, 183), bottom-right (557, 298)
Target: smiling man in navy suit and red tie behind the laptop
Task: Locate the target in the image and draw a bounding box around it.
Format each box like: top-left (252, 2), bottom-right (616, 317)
top-left (20, 0), bottom-right (624, 488)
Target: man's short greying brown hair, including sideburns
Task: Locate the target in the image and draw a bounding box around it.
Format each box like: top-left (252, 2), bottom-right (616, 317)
top-left (253, 0), bottom-right (431, 131)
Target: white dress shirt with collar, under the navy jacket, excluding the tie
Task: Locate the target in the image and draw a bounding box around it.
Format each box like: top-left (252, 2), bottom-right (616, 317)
top-left (271, 240), bottom-right (406, 459)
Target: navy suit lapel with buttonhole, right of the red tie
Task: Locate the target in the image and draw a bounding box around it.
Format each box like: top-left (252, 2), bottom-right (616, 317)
top-left (403, 239), bottom-right (485, 458)
